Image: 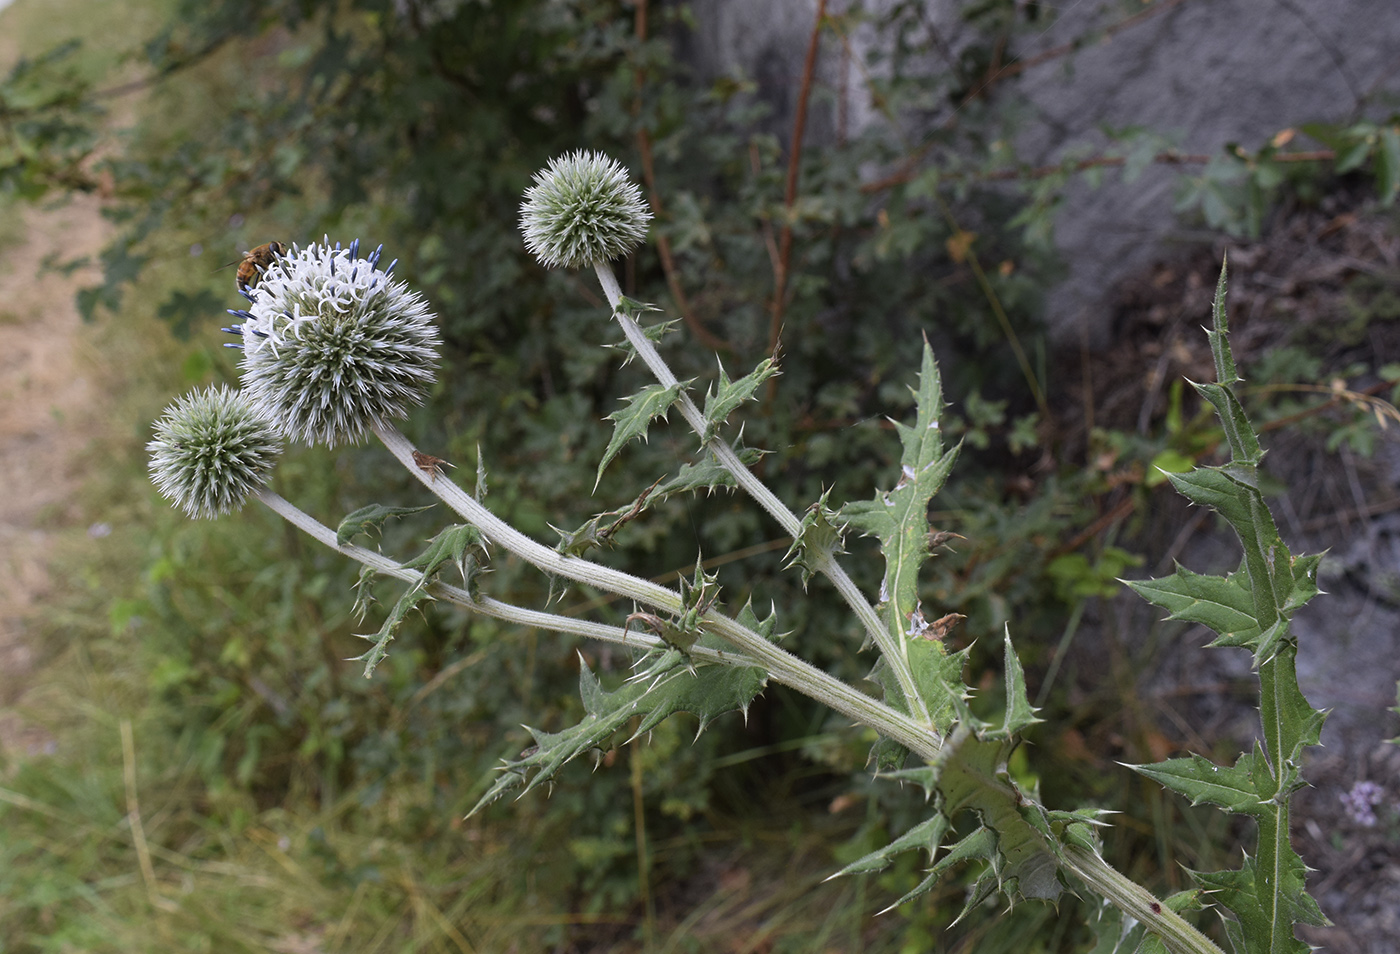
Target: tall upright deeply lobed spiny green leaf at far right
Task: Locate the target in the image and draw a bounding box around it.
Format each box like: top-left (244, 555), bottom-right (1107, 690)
top-left (1133, 260), bottom-right (1326, 954)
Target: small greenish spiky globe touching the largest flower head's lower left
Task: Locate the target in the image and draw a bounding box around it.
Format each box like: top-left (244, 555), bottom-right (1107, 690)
top-left (146, 387), bottom-right (281, 517)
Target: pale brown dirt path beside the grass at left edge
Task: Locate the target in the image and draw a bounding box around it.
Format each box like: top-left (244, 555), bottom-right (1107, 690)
top-left (0, 198), bottom-right (109, 749)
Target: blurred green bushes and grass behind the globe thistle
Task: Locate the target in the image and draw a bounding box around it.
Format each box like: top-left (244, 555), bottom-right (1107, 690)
top-left (0, 0), bottom-right (1400, 951)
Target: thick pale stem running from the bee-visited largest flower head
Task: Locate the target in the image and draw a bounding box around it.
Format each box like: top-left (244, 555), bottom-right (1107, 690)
top-left (369, 423), bottom-right (942, 761)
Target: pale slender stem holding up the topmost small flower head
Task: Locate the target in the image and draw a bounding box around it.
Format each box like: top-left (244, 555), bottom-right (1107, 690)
top-left (594, 262), bottom-right (931, 724)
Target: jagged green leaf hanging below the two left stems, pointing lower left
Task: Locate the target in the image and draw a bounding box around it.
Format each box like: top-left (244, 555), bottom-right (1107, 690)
top-left (470, 649), bottom-right (767, 814)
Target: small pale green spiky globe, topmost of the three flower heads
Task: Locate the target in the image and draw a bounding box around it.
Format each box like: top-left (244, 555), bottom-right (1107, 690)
top-left (521, 150), bottom-right (651, 268)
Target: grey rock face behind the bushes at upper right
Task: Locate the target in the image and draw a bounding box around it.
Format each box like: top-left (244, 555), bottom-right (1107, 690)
top-left (685, 0), bottom-right (1400, 342)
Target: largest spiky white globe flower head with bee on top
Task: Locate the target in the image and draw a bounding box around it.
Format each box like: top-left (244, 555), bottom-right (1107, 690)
top-left (225, 241), bottom-right (441, 447)
